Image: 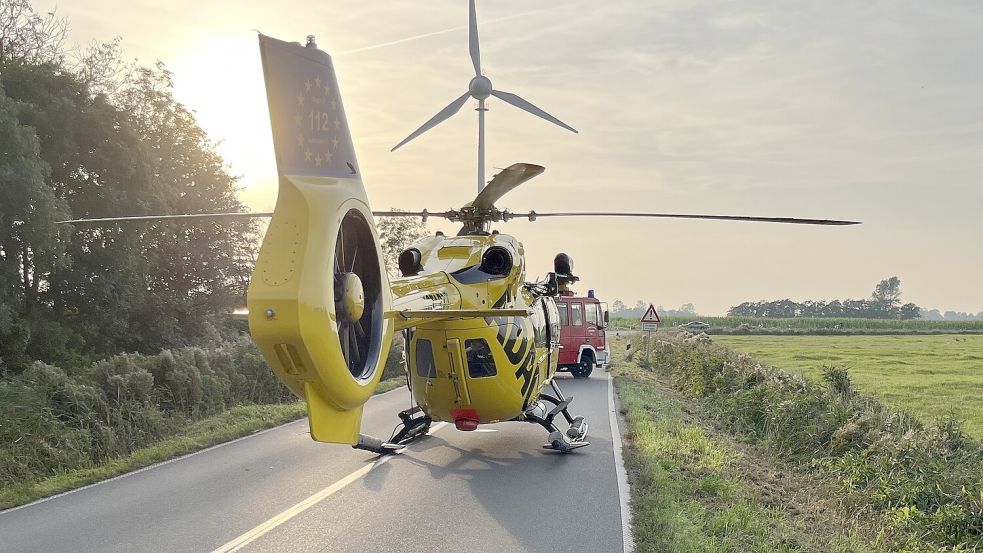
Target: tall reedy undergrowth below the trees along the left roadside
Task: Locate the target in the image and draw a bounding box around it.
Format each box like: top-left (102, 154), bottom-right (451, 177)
top-left (0, 337), bottom-right (294, 486)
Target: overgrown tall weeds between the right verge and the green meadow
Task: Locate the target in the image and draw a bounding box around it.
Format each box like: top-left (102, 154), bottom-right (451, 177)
top-left (614, 331), bottom-right (983, 552)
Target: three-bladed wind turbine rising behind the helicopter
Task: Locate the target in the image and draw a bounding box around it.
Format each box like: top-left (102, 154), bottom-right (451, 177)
top-left (390, 0), bottom-right (577, 192)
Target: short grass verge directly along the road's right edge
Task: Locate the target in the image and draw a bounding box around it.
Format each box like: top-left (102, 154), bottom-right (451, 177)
top-left (615, 352), bottom-right (881, 553)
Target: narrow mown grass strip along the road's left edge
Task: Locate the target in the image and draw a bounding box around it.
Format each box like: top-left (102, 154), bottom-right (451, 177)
top-left (0, 377), bottom-right (406, 511)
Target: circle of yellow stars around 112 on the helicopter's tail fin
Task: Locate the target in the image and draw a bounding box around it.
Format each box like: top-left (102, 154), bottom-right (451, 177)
top-left (294, 76), bottom-right (341, 167)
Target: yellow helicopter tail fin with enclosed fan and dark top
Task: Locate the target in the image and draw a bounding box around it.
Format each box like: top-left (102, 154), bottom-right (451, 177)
top-left (247, 35), bottom-right (393, 444)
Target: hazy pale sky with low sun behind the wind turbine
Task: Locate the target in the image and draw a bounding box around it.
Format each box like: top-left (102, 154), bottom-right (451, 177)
top-left (50, 0), bottom-right (983, 315)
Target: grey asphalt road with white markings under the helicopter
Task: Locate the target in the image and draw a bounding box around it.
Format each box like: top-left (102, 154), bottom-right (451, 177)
top-left (0, 370), bottom-right (625, 553)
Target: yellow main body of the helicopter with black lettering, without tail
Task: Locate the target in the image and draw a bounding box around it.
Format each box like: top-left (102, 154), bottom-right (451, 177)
top-left (391, 233), bottom-right (559, 424)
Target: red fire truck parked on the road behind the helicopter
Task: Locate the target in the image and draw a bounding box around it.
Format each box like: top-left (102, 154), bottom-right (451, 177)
top-left (553, 253), bottom-right (608, 378)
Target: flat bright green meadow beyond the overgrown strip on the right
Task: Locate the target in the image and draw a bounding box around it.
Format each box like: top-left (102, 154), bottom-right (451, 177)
top-left (713, 335), bottom-right (983, 438)
